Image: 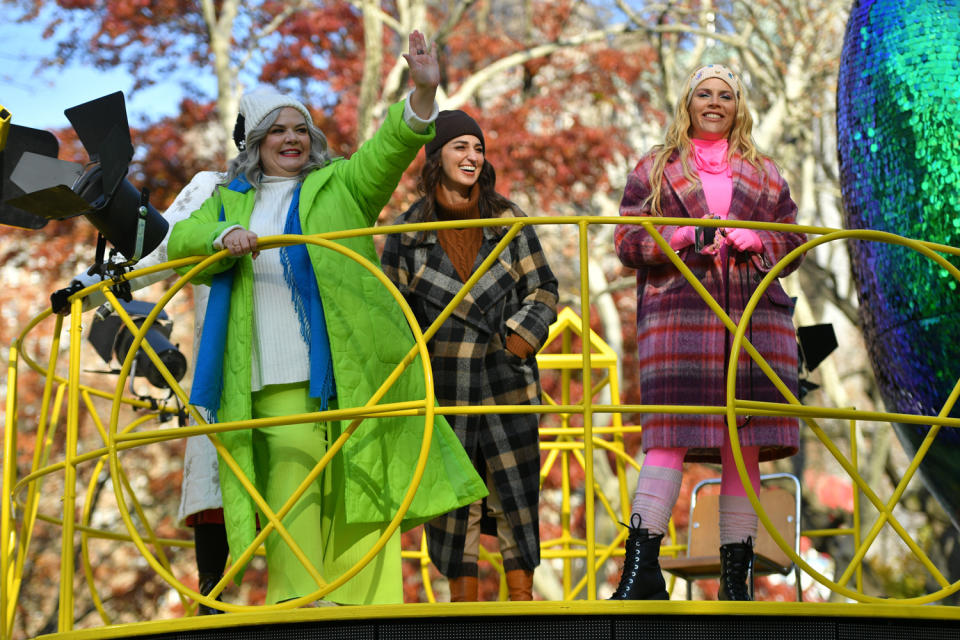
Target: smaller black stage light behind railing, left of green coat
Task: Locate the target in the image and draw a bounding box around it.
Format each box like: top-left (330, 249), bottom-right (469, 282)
top-left (87, 300), bottom-right (187, 389)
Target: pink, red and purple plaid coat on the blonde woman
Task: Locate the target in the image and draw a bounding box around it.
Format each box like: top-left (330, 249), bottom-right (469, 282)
top-left (614, 152), bottom-right (805, 462)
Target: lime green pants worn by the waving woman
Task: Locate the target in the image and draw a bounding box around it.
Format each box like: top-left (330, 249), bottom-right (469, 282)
top-left (253, 383), bottom-right (403, 604)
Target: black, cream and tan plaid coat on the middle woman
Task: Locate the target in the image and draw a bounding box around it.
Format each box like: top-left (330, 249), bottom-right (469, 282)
top-left (382, 201), bottom-right (557, 577)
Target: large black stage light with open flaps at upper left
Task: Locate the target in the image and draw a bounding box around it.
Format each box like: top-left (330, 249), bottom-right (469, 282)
top-left (0, 91), bottom-right (167, 268)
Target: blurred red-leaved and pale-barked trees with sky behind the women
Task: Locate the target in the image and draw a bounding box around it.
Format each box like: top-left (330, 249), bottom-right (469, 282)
top-left (0, 0), bottom-right (960, 637)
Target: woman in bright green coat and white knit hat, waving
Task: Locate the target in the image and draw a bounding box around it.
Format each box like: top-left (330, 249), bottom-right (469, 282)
top-left (168, 31), bottom-right (486, 604)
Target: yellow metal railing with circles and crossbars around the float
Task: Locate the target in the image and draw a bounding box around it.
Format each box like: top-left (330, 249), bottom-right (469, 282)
top-left (0, 216), bottom-right (960, 640)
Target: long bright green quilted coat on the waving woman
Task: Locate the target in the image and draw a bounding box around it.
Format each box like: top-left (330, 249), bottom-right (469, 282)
top-left (168, 102), bottom-right (487, 580)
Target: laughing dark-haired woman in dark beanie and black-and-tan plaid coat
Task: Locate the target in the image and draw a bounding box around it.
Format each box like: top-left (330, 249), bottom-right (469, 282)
top-left (382, 111), bottom-right (557, 602)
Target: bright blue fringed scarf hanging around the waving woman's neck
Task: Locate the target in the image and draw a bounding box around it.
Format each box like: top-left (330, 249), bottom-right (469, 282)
top-left (190, 176), bottom-right (336, 420)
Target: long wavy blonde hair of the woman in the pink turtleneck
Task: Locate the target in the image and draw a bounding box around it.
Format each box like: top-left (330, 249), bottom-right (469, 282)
top-left (644, 67), bottom-right (765, 216)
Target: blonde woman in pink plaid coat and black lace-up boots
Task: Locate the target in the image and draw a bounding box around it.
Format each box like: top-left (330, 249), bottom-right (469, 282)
top-left (613, 65), bottom-right (805, 600)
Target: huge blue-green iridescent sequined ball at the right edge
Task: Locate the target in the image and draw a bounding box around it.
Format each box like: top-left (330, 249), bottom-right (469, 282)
top-left (837, 0), bottom-right (960, 526)
